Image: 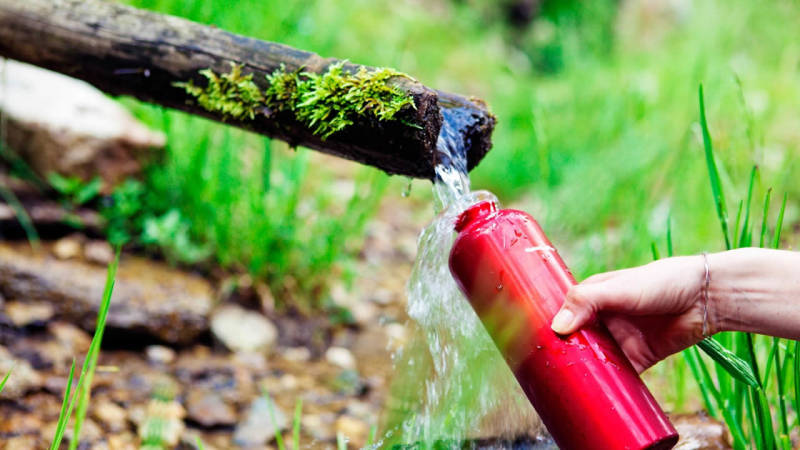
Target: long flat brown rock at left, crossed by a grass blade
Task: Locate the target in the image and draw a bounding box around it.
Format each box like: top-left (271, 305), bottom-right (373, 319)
top-left (0, 244), bottom-right (212, 343)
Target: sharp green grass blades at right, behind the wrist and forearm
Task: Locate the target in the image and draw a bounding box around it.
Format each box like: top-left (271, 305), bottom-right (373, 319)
top-left (654, 86), bottom-right (800, 450)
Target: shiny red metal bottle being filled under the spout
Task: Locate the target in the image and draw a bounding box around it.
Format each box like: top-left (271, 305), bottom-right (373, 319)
top-left (450, 201), bottom-right (678, 450)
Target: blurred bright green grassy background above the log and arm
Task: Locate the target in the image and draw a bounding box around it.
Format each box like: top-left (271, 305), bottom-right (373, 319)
top-left (115, 0), bottom-right (800, 302)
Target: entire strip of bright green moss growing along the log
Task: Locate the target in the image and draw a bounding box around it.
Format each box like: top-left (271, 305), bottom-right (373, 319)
top-left (176, 62), bottom-right (415, 139)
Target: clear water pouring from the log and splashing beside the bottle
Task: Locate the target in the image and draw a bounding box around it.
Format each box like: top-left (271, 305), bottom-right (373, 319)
top-left (379, 110), bottom-right (543, 448)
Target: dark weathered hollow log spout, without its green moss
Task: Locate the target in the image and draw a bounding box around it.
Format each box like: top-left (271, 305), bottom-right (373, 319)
top-left (0, 0), bottom-right (495, 179)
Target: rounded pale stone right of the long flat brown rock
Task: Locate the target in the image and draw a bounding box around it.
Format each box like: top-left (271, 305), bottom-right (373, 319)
top-left (211, 305), bottom-right (278, 352)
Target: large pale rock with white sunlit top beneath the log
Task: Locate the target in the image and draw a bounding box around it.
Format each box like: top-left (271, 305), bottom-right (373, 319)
top-left (0, 60), bottom-right (165, 187)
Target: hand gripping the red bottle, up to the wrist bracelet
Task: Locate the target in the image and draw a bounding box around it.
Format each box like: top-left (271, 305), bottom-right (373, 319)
top-left (552, 256), bottom-right (708, 372)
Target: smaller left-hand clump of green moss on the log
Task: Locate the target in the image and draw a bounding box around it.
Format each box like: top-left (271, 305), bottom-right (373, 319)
top-left (175, 63), bottom-right (264, 120)
